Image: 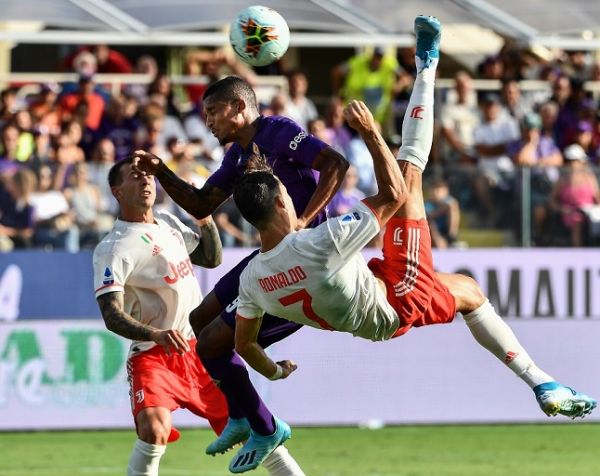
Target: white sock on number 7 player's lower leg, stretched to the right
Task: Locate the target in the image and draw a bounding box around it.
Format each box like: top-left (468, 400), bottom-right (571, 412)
top-left (463, 299), bottom-right (554, 388)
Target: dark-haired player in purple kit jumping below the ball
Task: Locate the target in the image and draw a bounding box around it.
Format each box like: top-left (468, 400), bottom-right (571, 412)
top-left (134, 76), bottom-right (348, 472)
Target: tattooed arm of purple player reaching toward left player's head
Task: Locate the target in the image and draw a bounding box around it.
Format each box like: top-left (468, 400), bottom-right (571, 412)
top-left (133, 150), bottom-right (227, 219)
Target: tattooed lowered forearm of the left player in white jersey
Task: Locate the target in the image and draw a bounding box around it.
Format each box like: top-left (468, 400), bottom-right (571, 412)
top-left (96, 292), bottom-right (190, 354)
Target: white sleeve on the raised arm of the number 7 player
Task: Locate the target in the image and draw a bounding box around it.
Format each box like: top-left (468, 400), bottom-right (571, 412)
top-left (321, 202), bottom-right (381, 259)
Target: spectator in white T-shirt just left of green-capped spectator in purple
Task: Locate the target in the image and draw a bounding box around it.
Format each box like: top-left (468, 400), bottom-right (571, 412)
top-left (474, 94), bottom-right (520, 226)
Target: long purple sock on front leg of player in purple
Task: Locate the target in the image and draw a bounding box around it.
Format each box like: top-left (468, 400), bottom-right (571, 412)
top-left (202, 351), bottom-right (275, 436)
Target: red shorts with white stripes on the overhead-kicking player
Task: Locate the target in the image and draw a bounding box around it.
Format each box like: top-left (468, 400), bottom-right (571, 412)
top-left (369, 217), bottom-right (456, 337)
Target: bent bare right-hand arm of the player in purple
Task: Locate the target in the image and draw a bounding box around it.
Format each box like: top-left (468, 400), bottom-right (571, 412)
top-left (297, 147), bottom-right (349, 229)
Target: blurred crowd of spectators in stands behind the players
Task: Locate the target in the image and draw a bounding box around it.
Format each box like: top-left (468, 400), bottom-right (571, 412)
top-left (0, 46), bottom-right (600, 252)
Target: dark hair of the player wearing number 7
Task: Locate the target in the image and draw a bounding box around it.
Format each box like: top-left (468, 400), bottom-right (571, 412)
top-left (233, 144), bottom-right (280, 230)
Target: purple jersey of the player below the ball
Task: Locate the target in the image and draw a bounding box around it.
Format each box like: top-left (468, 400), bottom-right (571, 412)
top-left (207, 116), bottom-right (328, 226)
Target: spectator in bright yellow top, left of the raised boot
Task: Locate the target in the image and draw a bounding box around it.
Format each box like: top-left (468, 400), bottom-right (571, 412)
top-left (332, 47), bottom-right (402, 125)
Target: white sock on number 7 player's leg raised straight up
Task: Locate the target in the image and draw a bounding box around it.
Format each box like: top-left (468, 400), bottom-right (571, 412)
top-left (398, 58), bottom-right (438, 170)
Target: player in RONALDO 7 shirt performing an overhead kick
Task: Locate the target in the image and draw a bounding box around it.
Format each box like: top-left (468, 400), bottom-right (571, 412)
top-left (234, 16), bottom-right (596, 464)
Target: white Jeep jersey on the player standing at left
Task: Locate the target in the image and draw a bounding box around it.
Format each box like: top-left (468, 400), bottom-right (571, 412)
top-left (94, 211), bottom-right (201, 353)
